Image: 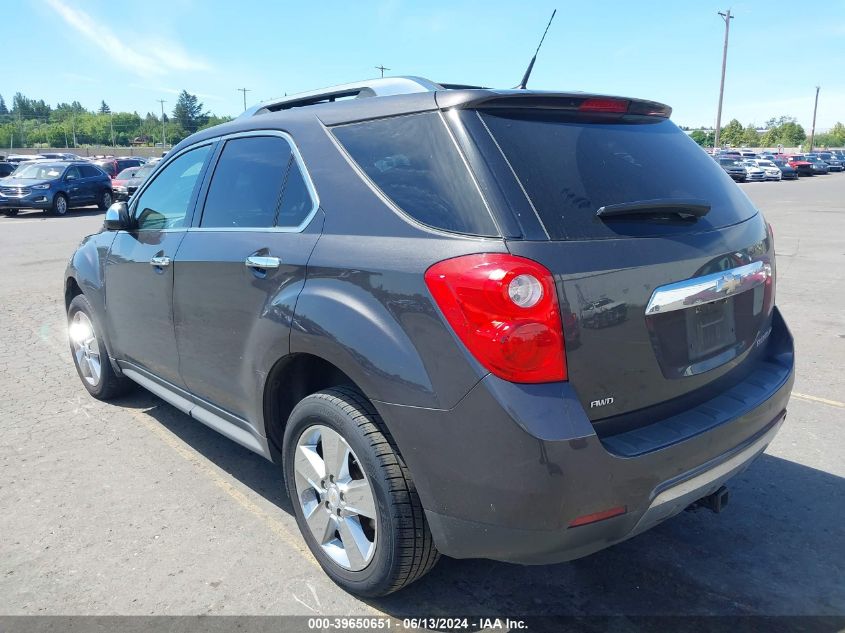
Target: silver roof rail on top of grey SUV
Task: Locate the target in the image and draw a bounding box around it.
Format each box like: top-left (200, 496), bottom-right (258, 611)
top-left (238, 77), bottom-right (443, 119)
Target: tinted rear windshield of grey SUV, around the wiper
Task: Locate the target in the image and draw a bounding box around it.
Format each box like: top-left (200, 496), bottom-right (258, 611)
top-left (480, 111), bottom-right (755, 240)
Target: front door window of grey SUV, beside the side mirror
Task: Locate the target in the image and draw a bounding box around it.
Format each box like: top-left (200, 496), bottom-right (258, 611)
top-left (135, 145), bottom-right (211, 230)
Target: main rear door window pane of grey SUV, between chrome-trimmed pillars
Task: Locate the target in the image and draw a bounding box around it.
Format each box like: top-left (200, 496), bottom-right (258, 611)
top-left (200, 136), bottom-right (291, 228)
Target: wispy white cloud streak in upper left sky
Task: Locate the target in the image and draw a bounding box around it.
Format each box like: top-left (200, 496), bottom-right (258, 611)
top-left (47, 0), bottom-right (209, 77)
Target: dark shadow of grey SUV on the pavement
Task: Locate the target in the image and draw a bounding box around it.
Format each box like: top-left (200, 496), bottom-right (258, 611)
top-left (115, 390), bottom-right (845, 619)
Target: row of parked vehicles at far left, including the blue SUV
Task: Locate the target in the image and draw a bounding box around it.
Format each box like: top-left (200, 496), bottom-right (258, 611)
top-left (0, 153), bottom-right (161, 216)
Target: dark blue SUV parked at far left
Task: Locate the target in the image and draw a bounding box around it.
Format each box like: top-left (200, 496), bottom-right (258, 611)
top-left (0, 161), bottom-right (113, 215)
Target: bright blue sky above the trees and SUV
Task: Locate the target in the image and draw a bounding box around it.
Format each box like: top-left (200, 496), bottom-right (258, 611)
top-left (6, 0), bottom-right (845, 131)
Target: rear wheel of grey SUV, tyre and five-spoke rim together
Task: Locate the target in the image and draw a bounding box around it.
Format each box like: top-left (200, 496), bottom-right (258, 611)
top-left (283, 387), bottom-right (440, 597)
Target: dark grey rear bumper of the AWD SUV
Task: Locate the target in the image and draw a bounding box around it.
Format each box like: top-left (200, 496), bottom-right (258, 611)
top-left (377, 306), bottom-right (794, 564)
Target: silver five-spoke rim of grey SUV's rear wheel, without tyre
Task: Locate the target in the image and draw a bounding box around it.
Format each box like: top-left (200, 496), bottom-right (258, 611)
top-left (293, 425), bottom-right (378, 571)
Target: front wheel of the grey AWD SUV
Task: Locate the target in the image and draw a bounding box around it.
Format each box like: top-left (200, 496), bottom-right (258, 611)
top-left (67, 295), bottom-right (133, 400)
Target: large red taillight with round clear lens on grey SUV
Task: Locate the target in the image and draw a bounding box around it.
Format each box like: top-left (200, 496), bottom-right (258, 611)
top-left (425, 253), bottom-right (567, 382)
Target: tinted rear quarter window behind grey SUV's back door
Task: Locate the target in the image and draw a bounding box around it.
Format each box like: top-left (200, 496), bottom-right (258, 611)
top-left (333, 113), bottom-right (498, 236)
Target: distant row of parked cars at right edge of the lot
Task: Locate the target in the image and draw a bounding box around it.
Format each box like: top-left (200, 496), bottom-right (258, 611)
top-left (712, 150), bottom-right (845, 182)
